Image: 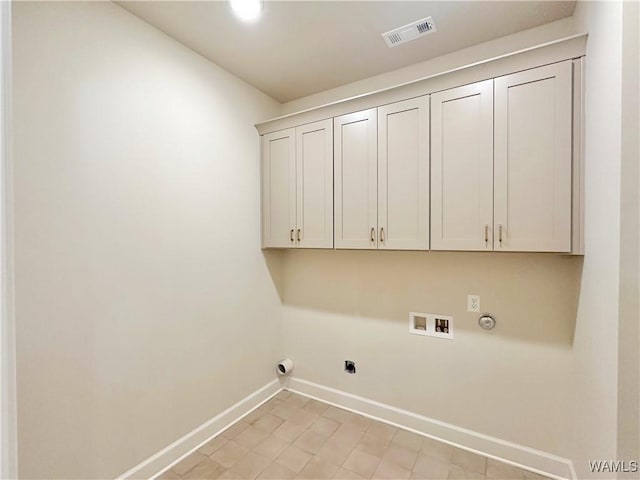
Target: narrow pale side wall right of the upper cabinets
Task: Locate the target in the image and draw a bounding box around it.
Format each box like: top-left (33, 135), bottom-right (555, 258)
top-left (568, 2), bottom-right (622, 478)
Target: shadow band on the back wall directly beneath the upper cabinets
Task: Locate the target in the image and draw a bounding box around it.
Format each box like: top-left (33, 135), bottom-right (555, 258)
top-left (278, 250), bottom-right (583, 346)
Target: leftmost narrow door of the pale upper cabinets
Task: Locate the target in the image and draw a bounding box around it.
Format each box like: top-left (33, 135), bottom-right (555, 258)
top-left (262, 128), bottom-right (296, 248)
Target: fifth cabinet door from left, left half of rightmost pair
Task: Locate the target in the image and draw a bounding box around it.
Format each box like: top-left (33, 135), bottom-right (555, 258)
top-left (431, 80), bottom-right (493, 251)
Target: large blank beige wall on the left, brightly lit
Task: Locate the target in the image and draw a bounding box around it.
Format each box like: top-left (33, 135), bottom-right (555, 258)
top-left (13, 2), bottom-right (281, 479)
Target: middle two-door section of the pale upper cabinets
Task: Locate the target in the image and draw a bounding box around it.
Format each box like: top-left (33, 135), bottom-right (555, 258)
top-left (334, 96), bottom-right (429, 250)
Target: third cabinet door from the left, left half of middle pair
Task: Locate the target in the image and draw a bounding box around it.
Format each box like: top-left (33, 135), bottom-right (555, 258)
top-left (333, 108), bottom-right (378, 249)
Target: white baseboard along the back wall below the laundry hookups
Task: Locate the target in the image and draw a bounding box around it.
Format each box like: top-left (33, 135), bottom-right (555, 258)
top-left (284, 377), bottom-right (576, 480)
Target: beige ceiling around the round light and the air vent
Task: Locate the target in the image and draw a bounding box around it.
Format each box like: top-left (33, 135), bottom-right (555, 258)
top-left (117, 0), bottom-right (575, 102)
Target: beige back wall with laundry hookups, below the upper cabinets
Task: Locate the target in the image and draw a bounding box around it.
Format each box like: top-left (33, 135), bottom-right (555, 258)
top-left (284, 251), bottom-right (582, 453)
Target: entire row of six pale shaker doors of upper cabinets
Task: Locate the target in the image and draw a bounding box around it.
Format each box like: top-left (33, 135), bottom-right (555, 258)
top-left (262, 54), bottom-right (583, 253)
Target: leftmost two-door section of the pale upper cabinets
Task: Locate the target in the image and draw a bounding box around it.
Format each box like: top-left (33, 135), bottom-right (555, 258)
top-left (262, 119), bottom-right (333, 248)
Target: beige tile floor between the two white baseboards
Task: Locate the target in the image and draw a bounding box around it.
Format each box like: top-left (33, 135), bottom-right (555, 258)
top-left (159, 391), bottom-right (544, 480)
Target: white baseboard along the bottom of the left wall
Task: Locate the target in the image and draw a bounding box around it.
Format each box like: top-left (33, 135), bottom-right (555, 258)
top-left (117, 379), bottom-right (282, 480)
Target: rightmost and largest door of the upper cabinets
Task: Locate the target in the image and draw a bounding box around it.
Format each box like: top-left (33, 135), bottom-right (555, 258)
top-left (494, 61), bottom-right (572, 252)
